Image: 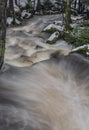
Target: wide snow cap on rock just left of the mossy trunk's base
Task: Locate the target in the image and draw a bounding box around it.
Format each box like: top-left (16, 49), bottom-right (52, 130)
top-left (43, 24), bottom-right (64, 31)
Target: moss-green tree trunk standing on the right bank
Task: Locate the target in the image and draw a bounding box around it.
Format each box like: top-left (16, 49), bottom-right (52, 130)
top-left (65, 0), bottom-right (71, 32)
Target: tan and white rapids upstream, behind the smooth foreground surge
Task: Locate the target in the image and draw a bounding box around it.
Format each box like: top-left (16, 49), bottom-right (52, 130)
top-left (5, 14), bottom-right (72, 67)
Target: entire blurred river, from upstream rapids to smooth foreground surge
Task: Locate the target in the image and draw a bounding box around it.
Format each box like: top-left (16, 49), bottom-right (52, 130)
top-left (0, 15), bottom-right (89, 130)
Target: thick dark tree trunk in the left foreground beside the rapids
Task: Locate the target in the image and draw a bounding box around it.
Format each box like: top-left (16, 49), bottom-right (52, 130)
top-left (0, 0), bottom-right (7, 70)
